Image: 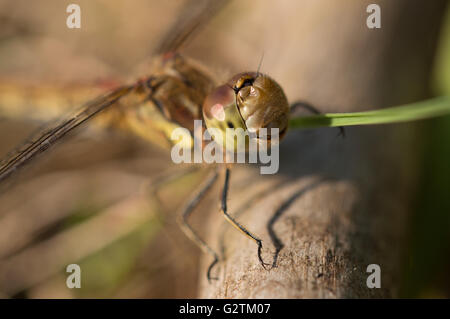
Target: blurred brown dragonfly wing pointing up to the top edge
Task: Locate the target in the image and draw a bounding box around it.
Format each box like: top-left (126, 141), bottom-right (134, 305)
top-left (155, 0), bottom-right (231, 54)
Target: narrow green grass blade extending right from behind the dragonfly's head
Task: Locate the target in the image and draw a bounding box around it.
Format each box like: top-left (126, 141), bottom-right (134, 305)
top-left (289, 96), bottom-right (450, 129)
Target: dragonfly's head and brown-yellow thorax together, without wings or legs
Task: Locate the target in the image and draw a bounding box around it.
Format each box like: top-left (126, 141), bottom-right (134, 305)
top-left (122, 54), bottom-right (290, 151)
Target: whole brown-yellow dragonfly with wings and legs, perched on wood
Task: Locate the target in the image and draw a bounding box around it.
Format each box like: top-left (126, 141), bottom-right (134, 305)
top-left (0, 0), bottom-right (338, 280)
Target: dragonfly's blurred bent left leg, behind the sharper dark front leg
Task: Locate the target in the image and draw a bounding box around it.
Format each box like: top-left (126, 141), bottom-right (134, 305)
top-left (178, 170), bottom-right (219, 282)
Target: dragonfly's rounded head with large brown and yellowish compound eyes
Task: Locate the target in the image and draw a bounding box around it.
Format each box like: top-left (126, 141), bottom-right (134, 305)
top-left (203, 72), bottom-right (289, 151)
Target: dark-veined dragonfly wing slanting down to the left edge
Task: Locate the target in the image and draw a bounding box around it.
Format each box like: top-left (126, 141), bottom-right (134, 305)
top-left (0, 86), bottom-right (134, 183)
